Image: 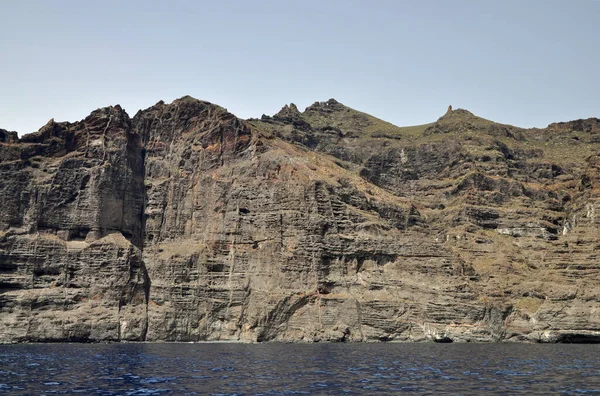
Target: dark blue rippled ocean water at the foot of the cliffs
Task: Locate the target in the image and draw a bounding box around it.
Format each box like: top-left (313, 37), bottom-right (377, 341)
top-left (0, 343), bottom-right (600, 395)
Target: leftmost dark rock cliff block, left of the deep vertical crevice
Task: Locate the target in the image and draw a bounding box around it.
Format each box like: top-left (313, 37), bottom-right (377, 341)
top-left (0, 106), bottom-right (149, 341)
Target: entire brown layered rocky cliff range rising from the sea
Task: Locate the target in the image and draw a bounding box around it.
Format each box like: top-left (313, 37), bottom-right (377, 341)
top-left (0, 97), bottom-right (600, 342)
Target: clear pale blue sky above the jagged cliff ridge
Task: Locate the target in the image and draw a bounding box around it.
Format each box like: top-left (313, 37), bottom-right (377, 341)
top-left (0, 0), bottom-right (600, 134)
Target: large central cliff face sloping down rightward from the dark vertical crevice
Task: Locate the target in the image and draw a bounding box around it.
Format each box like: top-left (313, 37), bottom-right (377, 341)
top-left (134, 98), bottom-right (477, 341)
